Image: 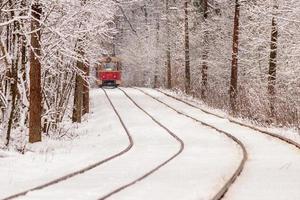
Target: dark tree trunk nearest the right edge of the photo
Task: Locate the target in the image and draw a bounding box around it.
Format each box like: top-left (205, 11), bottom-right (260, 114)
top-left (268, 6), bottom-right (278, 118)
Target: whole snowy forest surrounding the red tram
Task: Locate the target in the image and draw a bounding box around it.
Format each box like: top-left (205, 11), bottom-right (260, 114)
top-left (0, 0), bottom-right (300, 151)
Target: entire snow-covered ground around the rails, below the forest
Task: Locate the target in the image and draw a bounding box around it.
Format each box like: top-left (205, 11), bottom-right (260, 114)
top-left (0, 88), bottom-right (300, 200)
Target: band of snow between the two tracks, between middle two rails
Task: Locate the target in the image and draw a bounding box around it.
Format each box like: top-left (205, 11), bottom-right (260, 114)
top-left (111, 89), bottom-right (242, 200)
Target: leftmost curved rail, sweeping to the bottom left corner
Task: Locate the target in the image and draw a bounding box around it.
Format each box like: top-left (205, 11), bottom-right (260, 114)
top-left (2, 91), bottom-right (134, 200)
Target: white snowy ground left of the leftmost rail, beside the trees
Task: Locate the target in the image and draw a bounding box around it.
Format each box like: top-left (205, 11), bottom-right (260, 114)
top-left (0, 91), bottom-right (129, 199)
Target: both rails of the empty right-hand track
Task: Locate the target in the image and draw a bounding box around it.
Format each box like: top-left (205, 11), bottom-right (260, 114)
top-left (134, 88), bottom-right (300, 200)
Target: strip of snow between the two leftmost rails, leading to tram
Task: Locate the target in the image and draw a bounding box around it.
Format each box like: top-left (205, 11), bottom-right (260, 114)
top-left (12, 90), bottom-right (180, 199)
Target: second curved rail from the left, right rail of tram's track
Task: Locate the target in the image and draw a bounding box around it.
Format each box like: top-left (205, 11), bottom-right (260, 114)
top-left (98, 88), bottom-right (184, 200)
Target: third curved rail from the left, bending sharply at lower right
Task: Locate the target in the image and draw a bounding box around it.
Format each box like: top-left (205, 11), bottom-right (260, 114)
top-left (134, 88), bottom-right (248, 200)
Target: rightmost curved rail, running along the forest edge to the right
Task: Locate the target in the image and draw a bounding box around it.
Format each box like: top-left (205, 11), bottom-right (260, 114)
top-left (155, 89), bottom-right (300, 149)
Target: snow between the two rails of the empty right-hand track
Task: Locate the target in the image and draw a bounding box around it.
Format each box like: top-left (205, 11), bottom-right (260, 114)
top-left (139, 89), bottom-right (300, 200)
